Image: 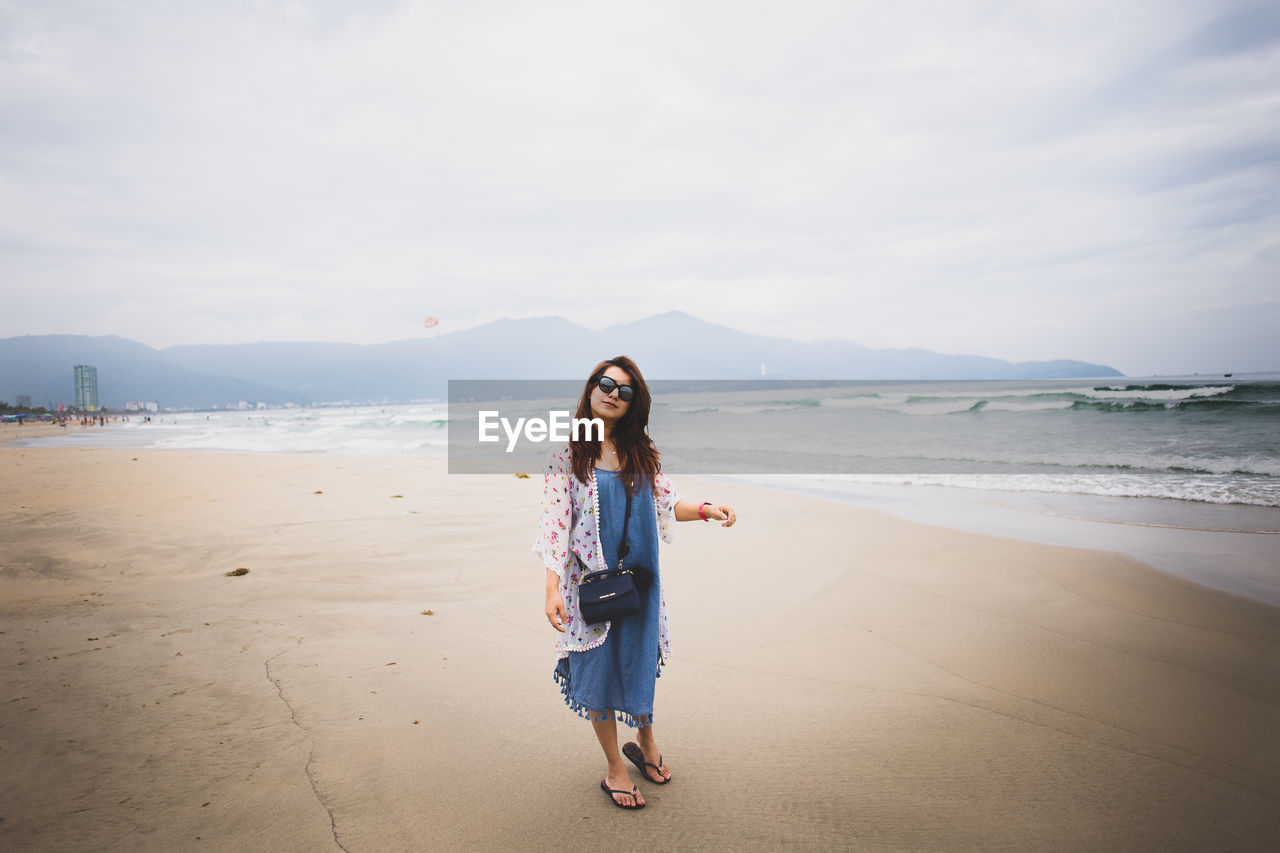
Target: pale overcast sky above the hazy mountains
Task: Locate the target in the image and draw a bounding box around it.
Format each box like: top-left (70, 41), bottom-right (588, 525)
top-left (0, 0), bottom-right (1280, 374)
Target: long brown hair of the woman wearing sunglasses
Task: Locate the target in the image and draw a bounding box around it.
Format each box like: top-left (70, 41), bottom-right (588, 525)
top-left (570, 356), bottom-right (662, 494)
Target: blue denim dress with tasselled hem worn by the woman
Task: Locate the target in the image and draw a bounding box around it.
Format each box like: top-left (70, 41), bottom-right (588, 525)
top-left (554, 467), bottom-right (660, 727)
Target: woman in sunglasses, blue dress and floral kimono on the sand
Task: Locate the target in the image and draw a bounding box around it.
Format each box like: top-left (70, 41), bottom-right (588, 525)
top-left (534, 356), bottom-right (737, 808)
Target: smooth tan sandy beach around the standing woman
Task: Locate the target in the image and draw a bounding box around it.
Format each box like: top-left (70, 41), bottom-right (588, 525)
top-left (0, 445), bottom-right (1280, 852)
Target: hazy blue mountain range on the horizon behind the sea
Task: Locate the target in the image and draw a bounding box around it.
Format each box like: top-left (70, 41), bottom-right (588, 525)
top-left (0, 311), bottom-right (1124, 409)
